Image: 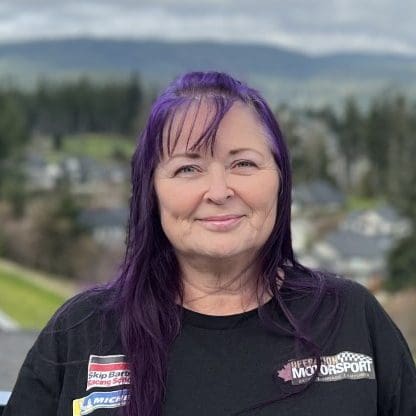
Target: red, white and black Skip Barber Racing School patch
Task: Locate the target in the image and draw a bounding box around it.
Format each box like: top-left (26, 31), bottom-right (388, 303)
top-left (87, 355), bottom-right (130, 390)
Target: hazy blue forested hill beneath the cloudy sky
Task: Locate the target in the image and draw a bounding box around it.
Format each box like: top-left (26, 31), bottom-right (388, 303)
top-left (0, 38), bottom-right (416, 106)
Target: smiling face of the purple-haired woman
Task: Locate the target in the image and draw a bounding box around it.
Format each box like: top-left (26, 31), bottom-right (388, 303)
top-left (154, 103), bottom-right (279, 259)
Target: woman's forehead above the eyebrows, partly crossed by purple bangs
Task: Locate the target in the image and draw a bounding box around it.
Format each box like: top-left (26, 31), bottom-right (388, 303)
top-left (163, 101), bottom-right (269, 157)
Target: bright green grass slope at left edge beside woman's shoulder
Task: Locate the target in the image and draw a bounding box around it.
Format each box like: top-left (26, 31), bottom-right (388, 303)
top-left (0, 261), bottom-right (75, 329)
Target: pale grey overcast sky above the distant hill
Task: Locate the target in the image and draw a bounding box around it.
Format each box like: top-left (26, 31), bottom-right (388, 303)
top-left (0, 0), bottom-right (416, 55)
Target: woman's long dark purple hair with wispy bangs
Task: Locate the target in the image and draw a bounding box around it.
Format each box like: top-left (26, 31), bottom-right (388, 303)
top-left (108, 72), bottom-right (341, 416)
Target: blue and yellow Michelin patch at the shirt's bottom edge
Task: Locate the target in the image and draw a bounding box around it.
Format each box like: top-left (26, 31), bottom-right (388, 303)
top-left (72, 390), bottom-right (129, 416)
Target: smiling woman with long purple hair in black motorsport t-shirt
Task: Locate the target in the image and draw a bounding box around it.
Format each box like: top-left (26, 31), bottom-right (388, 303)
top-left (5, 72), bottom-right (416, 416)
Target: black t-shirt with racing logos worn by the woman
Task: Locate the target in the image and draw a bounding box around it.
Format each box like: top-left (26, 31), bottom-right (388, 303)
top-left (4, 281), bottom-right (416, 416)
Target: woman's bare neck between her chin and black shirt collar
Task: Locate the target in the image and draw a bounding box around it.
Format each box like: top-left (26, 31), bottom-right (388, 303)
top-left (178, 255), bottom-right (271, 315)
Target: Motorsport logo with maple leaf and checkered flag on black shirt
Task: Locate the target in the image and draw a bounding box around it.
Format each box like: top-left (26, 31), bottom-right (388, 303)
top-left (278, 351), bottom-right (375, 385)
